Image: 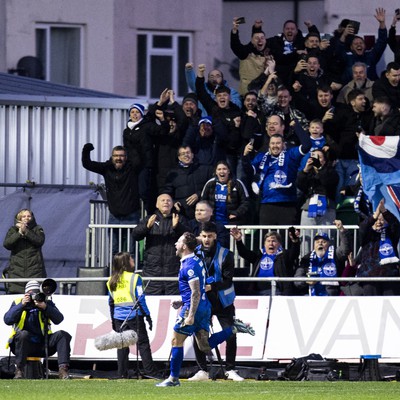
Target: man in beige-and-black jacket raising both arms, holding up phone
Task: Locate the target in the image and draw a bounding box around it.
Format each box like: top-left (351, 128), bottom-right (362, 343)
top-left (231, 17), bottom-right (269, 96)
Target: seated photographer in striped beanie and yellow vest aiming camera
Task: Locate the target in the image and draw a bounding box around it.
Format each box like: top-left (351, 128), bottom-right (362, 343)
top-left (4, 281), bottom-right (71, 379)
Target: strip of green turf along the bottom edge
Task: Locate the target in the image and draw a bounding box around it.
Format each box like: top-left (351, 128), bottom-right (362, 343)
top-left (0, 379), bottom-right (400, 400)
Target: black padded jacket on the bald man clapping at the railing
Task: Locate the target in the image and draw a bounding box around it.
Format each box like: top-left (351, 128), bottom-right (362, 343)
top-left (132, 210), bottom-right (189, 295)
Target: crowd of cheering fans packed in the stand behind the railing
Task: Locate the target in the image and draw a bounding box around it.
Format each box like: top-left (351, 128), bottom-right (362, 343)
top-left (82, 8), bottom-right (400, 295)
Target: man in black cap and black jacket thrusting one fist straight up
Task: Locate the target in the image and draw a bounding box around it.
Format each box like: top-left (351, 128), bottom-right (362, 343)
top-left (196, 64), bottom-right (241, 176)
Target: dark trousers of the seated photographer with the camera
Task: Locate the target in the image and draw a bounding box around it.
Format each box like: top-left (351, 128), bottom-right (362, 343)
top-left (10, 331), bottom-right (72, 369)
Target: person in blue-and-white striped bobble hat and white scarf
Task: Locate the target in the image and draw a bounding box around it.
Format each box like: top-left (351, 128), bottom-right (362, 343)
top-left (122, 103), bottom-right (160, 214)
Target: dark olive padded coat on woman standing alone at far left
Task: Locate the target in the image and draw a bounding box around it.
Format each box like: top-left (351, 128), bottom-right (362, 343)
top-left (3, 213), bottom-right (47, 293)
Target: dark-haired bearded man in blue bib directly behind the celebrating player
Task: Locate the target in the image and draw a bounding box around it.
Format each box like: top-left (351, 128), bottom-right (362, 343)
top-left (189, 222), bottom-right (244, 381)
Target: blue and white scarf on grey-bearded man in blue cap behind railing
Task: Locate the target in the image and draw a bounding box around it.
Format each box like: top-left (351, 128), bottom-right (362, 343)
top-left (308, 245), bottom-right (339, 296)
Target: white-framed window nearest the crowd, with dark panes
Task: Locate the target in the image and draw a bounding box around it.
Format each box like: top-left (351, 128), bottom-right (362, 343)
top-left (137, 32), bottom-right (191, 99)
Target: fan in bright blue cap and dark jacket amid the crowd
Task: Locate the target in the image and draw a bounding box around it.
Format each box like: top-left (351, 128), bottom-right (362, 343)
top-left (182, 116), bottom-right (229, 166)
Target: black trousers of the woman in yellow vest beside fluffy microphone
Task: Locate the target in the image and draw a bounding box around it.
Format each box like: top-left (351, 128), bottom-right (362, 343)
top-left (115, 316), bottom-right (156, 378)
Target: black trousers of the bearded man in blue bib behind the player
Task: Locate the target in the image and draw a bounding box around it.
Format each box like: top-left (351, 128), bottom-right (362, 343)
top-left (193, 304), bottom-right (237, 371)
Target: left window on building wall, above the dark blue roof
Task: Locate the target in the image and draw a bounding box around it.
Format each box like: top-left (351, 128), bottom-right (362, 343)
top-left (36, 24), bottom-right (83, 86)
